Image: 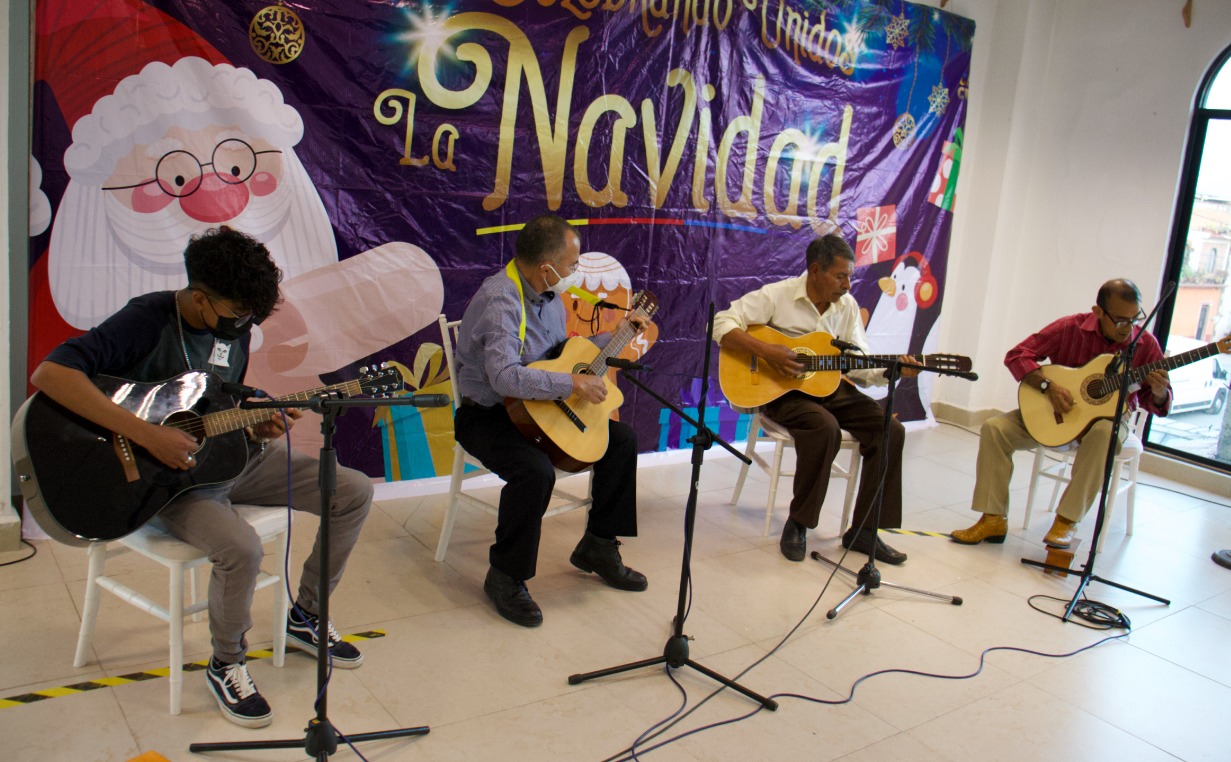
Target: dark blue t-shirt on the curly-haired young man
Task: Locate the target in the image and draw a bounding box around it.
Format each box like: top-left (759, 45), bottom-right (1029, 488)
top-left (47, 291), bottom-right (251, 383)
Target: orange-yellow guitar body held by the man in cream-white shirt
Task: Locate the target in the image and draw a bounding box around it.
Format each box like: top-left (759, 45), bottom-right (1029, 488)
top-left (718, 325), bottom-right (842, 407)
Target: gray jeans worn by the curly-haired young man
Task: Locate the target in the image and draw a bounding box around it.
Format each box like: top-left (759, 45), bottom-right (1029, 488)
top-left (155, 439), bottom-right (372, 664)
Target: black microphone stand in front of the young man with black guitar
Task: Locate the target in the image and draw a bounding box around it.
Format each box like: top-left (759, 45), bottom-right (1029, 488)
top-left (188, 393), bottom-right (431, 762)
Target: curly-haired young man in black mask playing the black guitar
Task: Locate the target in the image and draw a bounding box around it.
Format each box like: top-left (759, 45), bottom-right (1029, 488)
top-left (31, 227), bottom-right (372, 728)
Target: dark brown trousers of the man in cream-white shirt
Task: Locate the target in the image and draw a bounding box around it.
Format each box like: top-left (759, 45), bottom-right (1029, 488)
top-left (763, 380), bottom-right (906, 529)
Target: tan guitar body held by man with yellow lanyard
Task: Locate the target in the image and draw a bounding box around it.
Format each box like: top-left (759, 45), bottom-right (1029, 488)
top-left (505, 337), bottom-right (624, 471)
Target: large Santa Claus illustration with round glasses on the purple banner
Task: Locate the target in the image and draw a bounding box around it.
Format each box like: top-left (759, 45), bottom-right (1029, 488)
top-left (30, 0), bottom-right (443, 406)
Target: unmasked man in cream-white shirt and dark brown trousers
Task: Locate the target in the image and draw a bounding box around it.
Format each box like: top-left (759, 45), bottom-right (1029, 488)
top-left (714, 234), bottom-right (918, 564)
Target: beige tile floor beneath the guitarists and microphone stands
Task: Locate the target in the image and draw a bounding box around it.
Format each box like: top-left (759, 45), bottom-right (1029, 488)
top-left (0, 426), bottom-right (1231, 762)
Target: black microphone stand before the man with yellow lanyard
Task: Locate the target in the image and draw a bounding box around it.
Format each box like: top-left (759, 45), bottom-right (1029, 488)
top-left (569, 302), bottom-right (778, 712)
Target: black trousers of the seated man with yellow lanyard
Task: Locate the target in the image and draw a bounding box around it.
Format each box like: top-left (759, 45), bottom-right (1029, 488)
top-left (453, 405), bottom-right (636, 580)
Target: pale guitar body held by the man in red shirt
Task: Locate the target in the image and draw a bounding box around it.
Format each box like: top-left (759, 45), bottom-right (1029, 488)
top-left (1017, 355), bottom-right (1117, 447)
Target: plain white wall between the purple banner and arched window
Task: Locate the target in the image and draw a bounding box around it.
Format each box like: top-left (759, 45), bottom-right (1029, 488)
top-left (932, 0), bottom-right (1231, 411)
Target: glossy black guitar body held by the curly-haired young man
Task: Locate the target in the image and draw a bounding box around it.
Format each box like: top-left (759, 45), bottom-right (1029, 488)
top-left (12, 371), bottom-right (247, 545)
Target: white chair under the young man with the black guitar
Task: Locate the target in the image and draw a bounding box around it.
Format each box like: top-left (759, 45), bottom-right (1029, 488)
top-left (73, 506), bottom-right (288, 714)
